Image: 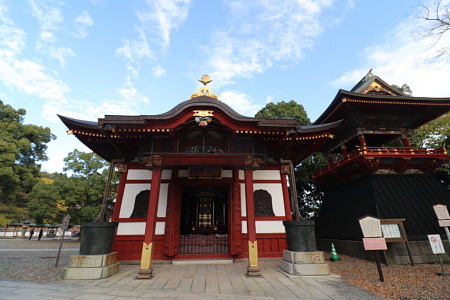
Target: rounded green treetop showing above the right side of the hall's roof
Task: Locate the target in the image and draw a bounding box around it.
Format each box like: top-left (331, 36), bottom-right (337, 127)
top-left (255, 100), bottom-right (311, 125)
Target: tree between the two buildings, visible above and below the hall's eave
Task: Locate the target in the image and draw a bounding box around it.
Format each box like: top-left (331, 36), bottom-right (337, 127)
top-left (255, 100), bottom-right (326, 219)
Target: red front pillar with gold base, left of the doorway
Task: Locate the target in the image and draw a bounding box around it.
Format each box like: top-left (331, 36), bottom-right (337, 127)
top-left (138, 169), bottom-right (162, 278)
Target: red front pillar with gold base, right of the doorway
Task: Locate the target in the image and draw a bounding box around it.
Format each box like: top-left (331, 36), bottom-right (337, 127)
top-left (245, 170), bottom-right (261, 276)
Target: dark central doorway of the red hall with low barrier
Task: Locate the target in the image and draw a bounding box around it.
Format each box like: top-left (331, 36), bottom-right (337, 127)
top-left (178, 186), bottom-right (228, 254)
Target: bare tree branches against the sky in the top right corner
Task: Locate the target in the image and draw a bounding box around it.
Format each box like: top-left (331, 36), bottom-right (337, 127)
top-left (422, 0), bottom-right (450, 58)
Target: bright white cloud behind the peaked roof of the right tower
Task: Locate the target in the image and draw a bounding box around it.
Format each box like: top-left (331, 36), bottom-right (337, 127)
top-left (331, 12), bottom-right (450, 97)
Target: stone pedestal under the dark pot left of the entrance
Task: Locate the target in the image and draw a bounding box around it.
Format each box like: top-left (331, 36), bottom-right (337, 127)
top-left (63, 252), bottom-right (119, 280)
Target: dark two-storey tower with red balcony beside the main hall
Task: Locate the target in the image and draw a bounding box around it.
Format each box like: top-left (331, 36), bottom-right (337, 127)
top-left (314, 72), bottom-right (450, 263)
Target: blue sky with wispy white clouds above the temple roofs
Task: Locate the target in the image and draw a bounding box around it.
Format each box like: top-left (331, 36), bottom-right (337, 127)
top-left (0, 0), bottom-right (450, 172)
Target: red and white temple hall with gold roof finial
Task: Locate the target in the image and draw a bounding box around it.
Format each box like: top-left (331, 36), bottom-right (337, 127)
top-left (60, 75), bottom-right (341, 278)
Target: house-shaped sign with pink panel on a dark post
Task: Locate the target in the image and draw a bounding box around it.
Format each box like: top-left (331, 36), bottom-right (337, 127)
top-left (358, 216), bottom-right (387, 282)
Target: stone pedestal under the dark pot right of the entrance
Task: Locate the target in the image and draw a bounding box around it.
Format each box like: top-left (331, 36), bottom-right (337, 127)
top-left (281, 250), bottom-right (331, 276)
